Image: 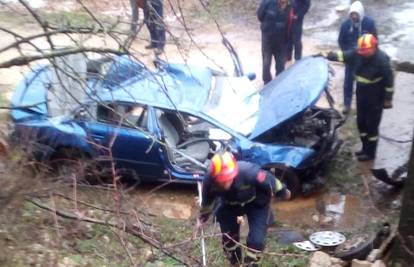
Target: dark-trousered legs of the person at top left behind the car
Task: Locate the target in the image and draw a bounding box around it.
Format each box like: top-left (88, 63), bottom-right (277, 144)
top-left (144, 0), bottom-right (165, 50)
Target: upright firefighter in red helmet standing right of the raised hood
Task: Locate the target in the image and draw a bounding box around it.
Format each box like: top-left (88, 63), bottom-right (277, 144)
top-left (327, 34), bottom-right (394, 161)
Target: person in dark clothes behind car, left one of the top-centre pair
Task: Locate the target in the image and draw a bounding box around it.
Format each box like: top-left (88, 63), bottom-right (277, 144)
top-left (257, 0), bottom-right (294, 84)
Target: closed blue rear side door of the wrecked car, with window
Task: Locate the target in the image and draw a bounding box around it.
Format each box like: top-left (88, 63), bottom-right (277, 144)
top-left (79, 102), bottom-right (165, 179)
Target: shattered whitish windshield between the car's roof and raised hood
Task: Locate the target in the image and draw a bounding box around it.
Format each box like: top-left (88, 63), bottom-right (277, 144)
top-left (203, 77), bottom-right (260, 136)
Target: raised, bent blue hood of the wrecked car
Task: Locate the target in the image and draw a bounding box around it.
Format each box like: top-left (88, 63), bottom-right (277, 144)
top-left (249, 57), bottom-right (329, 140)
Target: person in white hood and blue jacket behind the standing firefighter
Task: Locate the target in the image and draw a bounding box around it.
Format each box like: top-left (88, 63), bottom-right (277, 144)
top-left (338, 1), bottom-right (377, 115)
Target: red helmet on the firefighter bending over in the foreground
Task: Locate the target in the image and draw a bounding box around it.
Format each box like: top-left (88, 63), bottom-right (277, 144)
top-left (210, 152), bottom-right (239, 183)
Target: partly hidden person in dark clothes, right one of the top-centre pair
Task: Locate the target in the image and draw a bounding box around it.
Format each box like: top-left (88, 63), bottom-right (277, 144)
top-left (288, 0), bottom-right (311, 60)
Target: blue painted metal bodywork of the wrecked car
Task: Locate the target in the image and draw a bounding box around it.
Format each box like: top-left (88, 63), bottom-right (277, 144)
top-left (12, 56), bottom-right (327, 181)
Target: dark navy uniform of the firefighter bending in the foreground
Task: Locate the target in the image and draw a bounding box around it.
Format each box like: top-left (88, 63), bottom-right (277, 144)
top-left (200, 161), bottom-right (286, 266)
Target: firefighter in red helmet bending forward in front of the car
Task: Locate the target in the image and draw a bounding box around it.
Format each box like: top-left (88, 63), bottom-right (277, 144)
top-left (199, 152), bottom-right (291, 266)
